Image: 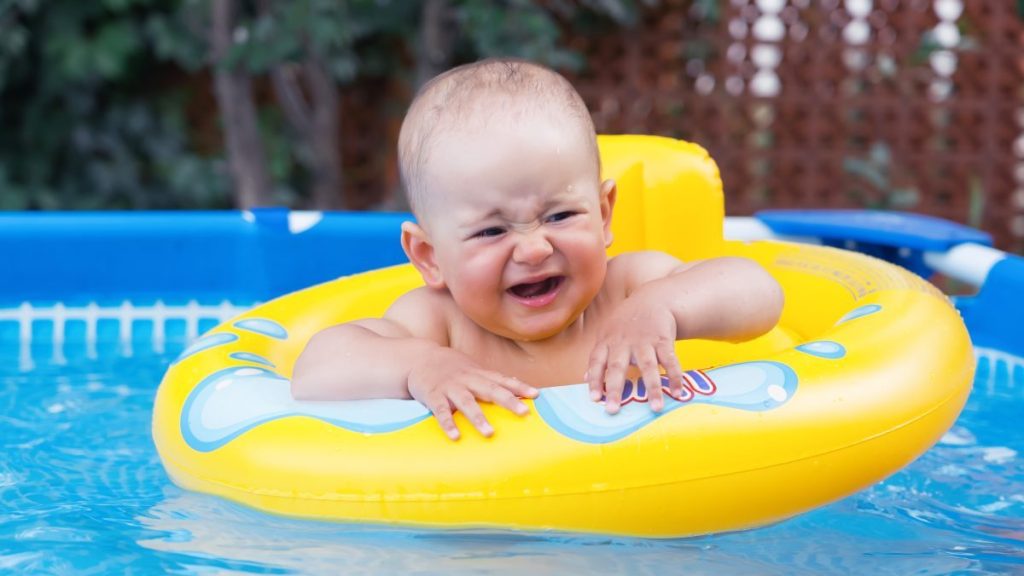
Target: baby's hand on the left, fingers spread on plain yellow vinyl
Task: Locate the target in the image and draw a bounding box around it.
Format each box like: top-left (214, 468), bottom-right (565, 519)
top-left (409, 347), bottom-right (538, 440)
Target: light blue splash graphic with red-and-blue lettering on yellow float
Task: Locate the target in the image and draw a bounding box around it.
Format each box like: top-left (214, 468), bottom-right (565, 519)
top-left (535, 361), bottom-right (797, 444)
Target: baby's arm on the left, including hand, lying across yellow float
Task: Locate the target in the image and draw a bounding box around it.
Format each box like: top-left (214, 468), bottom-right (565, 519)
top-left (292, 292), bottom-right (537, 440)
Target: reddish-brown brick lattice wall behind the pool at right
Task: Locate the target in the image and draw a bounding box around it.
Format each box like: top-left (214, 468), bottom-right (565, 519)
top-left (572, 0), bottom-right (1024, 251)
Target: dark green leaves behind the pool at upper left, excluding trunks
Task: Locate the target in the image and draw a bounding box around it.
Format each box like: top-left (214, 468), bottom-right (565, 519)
top-left (0, 0), bottom-right (655, 209)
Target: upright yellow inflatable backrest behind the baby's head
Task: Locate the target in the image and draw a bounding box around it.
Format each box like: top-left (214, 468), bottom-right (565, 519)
top-left (597, 135), bottom-right (725, 260)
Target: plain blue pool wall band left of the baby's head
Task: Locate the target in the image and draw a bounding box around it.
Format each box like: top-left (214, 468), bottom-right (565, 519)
top-left (0, 208), bottom-right (411, 308)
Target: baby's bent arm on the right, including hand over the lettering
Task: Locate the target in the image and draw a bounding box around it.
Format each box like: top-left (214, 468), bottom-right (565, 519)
top-left (587, 252), bottom-right (782, 413)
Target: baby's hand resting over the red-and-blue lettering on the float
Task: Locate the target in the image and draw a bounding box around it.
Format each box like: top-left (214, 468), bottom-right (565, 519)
top-left (587, 295), bottom-right (683, 414)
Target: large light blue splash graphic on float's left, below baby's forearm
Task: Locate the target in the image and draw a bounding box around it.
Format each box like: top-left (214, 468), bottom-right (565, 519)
top-left (181, 366), bottom-right (430, 452)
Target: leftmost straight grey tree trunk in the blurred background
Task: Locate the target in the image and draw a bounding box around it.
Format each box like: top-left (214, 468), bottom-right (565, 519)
top-left (210, 0), bottom-right (272, 209)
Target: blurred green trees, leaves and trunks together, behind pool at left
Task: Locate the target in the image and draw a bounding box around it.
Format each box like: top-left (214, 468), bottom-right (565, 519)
top-left (0, 0), bottom-right (638, 210)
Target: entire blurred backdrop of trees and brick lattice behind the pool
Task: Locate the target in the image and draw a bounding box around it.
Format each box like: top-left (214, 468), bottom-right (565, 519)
top-left (0, 0), bottom-right (1024, 251)
